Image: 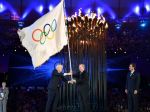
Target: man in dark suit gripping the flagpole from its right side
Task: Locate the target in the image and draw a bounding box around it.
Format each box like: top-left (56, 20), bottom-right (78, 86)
top-left (73, 64), bottom-right (92, 112)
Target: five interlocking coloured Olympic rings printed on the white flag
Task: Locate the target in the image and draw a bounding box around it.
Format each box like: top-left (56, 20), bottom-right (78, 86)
top-left (32, 19), bottom-right (57, 44)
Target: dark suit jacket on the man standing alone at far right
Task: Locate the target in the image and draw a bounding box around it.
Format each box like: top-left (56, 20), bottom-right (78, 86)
top-left (126, 71), bottom-right (140, 92)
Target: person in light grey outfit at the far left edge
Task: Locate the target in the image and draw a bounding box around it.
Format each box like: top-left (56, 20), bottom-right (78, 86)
top-left (0, 82), bottom-right (9, 112)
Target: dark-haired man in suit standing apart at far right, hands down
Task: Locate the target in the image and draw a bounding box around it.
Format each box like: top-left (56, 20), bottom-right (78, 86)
top-left (125, 63), bottom-right (140, 112)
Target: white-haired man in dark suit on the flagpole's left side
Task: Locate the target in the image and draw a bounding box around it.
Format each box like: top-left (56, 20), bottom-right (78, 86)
top-left (45, 64), bottom-right (72, 112)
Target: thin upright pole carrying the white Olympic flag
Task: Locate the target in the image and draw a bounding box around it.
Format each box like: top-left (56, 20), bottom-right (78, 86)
top-left (63, 0), bottom-right (73, 80)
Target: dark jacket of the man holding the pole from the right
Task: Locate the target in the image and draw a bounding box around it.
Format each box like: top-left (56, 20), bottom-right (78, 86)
top-left (73, 71), bottom-right (89, 89)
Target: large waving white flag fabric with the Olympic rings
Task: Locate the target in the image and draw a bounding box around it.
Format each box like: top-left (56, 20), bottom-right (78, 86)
top-left (18, 0), bottom-right (68, 68)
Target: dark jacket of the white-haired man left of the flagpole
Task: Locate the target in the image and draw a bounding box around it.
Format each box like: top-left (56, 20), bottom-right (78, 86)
top-left (48, 70), bottom-right (67, 90)
